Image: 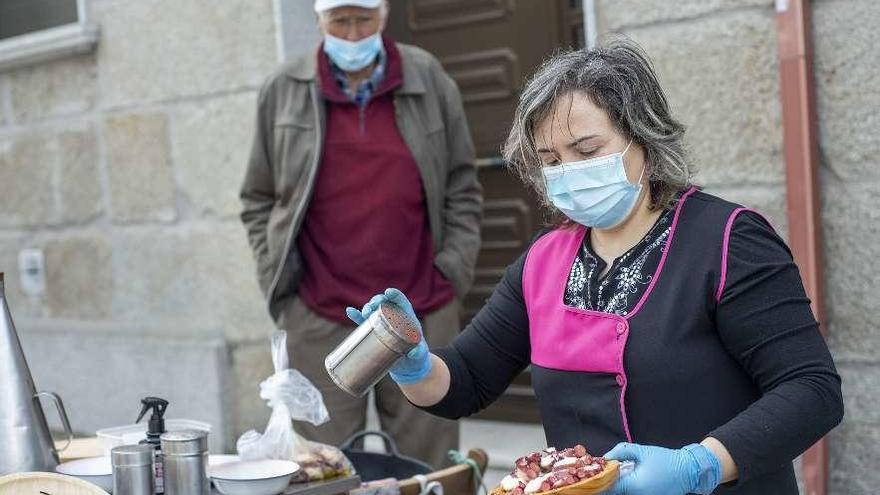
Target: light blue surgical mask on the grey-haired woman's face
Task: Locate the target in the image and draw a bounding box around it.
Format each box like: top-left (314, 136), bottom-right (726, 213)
top-left (541, 140), bottom-right (645, 229)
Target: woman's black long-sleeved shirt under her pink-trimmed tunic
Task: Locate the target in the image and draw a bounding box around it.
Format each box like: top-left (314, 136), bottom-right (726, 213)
top-left (424, 212), bottom-right (843, 488)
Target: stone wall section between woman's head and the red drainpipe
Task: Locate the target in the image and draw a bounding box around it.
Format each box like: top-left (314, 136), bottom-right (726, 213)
top-left (597, 0), bottom-right (786, 232)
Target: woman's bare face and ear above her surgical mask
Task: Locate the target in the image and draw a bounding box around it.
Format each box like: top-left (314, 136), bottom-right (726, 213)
top-left (535, 92), bottom-right (648, 184)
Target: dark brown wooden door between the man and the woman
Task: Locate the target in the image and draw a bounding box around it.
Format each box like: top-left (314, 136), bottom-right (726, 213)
top-left (386, 0), bottom-right (584, 422)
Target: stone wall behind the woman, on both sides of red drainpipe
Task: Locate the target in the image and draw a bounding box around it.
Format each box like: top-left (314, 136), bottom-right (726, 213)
top-left (597, 0), bottom-right (880, 495)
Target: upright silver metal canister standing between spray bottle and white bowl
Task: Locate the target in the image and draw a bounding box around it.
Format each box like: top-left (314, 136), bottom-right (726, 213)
top-left (160, 430), bottom-right (211, 495)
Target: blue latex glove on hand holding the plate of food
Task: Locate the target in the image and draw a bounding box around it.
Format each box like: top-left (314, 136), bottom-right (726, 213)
top-left (605, 443), bottom-right (721, 495)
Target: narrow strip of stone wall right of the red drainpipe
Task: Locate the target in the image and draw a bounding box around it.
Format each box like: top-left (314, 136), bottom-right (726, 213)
top-left (813, 0), bottom-right (880, 494)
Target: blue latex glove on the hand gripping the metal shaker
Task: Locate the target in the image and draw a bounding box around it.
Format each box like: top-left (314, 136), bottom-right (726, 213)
top-left (345, 288), bottom-right (431, 385)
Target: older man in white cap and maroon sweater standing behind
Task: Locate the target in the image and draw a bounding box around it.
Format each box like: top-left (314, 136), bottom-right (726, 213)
top-left (241, 0), bottom-right (481, 467)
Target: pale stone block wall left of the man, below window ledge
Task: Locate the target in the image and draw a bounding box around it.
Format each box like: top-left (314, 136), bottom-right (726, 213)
top-left (0, 0), bottom-right (290, 451)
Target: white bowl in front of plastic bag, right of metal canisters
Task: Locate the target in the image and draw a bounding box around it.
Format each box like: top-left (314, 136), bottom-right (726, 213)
top-left (208, 459), bottom-right (299, 495)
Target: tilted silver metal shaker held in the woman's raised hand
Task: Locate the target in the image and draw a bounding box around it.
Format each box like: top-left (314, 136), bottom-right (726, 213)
top-left (324, 303), bottom-right (422, 397)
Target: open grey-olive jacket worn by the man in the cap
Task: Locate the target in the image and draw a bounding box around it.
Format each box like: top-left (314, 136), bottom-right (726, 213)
top-left (240, 44), bottom-right (482, 320)
